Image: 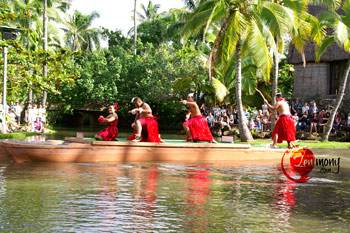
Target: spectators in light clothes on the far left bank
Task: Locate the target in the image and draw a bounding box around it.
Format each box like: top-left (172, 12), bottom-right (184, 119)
top-left (0, 102), bottom-right (46, 133)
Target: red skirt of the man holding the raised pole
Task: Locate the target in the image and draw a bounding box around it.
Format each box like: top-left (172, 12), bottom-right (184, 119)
top-left (272, 115), bottom-right (296, 143)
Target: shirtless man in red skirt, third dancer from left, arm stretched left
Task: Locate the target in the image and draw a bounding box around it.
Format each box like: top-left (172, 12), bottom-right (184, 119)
top-left (181, 94), bottom-right (216, 143)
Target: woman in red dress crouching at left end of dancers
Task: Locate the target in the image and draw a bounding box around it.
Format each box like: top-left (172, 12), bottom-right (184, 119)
top-left (95, 103), bottom-right (119, 141)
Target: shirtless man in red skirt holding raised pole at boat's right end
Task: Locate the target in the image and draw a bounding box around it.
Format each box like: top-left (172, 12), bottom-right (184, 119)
top-left (259, 91), bottom-right (296, 149)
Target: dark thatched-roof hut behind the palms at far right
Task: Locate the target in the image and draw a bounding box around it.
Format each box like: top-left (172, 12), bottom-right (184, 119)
top-left (287, 6), bottom-right (350, 109)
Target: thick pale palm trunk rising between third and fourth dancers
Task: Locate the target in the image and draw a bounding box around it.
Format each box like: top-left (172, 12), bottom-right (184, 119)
top-left (236, 40), bottom-right (254, 142)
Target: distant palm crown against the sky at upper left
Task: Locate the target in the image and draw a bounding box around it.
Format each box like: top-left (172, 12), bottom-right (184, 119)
top-left (63, 11), bottom-right (101, 51)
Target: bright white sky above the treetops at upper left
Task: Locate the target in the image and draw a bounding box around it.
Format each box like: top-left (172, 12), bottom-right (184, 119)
top-left (72, 0), bottom-right (184, 34)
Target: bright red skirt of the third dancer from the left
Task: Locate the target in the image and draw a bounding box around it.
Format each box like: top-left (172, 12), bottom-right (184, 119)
top-left (183, 116), bottom-right (214, 142)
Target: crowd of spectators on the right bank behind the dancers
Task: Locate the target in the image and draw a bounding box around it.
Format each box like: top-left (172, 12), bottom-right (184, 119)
top-left (201, 99), bottom-right (350, 135)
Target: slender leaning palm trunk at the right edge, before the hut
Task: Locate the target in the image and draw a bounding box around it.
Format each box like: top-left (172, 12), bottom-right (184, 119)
top-left (322, 59), bottom-right (350, 141)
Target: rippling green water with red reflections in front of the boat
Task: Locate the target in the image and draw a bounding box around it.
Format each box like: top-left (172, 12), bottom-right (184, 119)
top-left (0, 160), bottom-right (350, 232)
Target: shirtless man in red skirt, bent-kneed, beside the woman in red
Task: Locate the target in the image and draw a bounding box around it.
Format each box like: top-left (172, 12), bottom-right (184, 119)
top-left (128, 97), bottom-right (161, 143)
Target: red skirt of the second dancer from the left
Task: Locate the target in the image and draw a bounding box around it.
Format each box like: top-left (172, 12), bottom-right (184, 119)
top-left (128, 117), bottom-right (160, 143)
